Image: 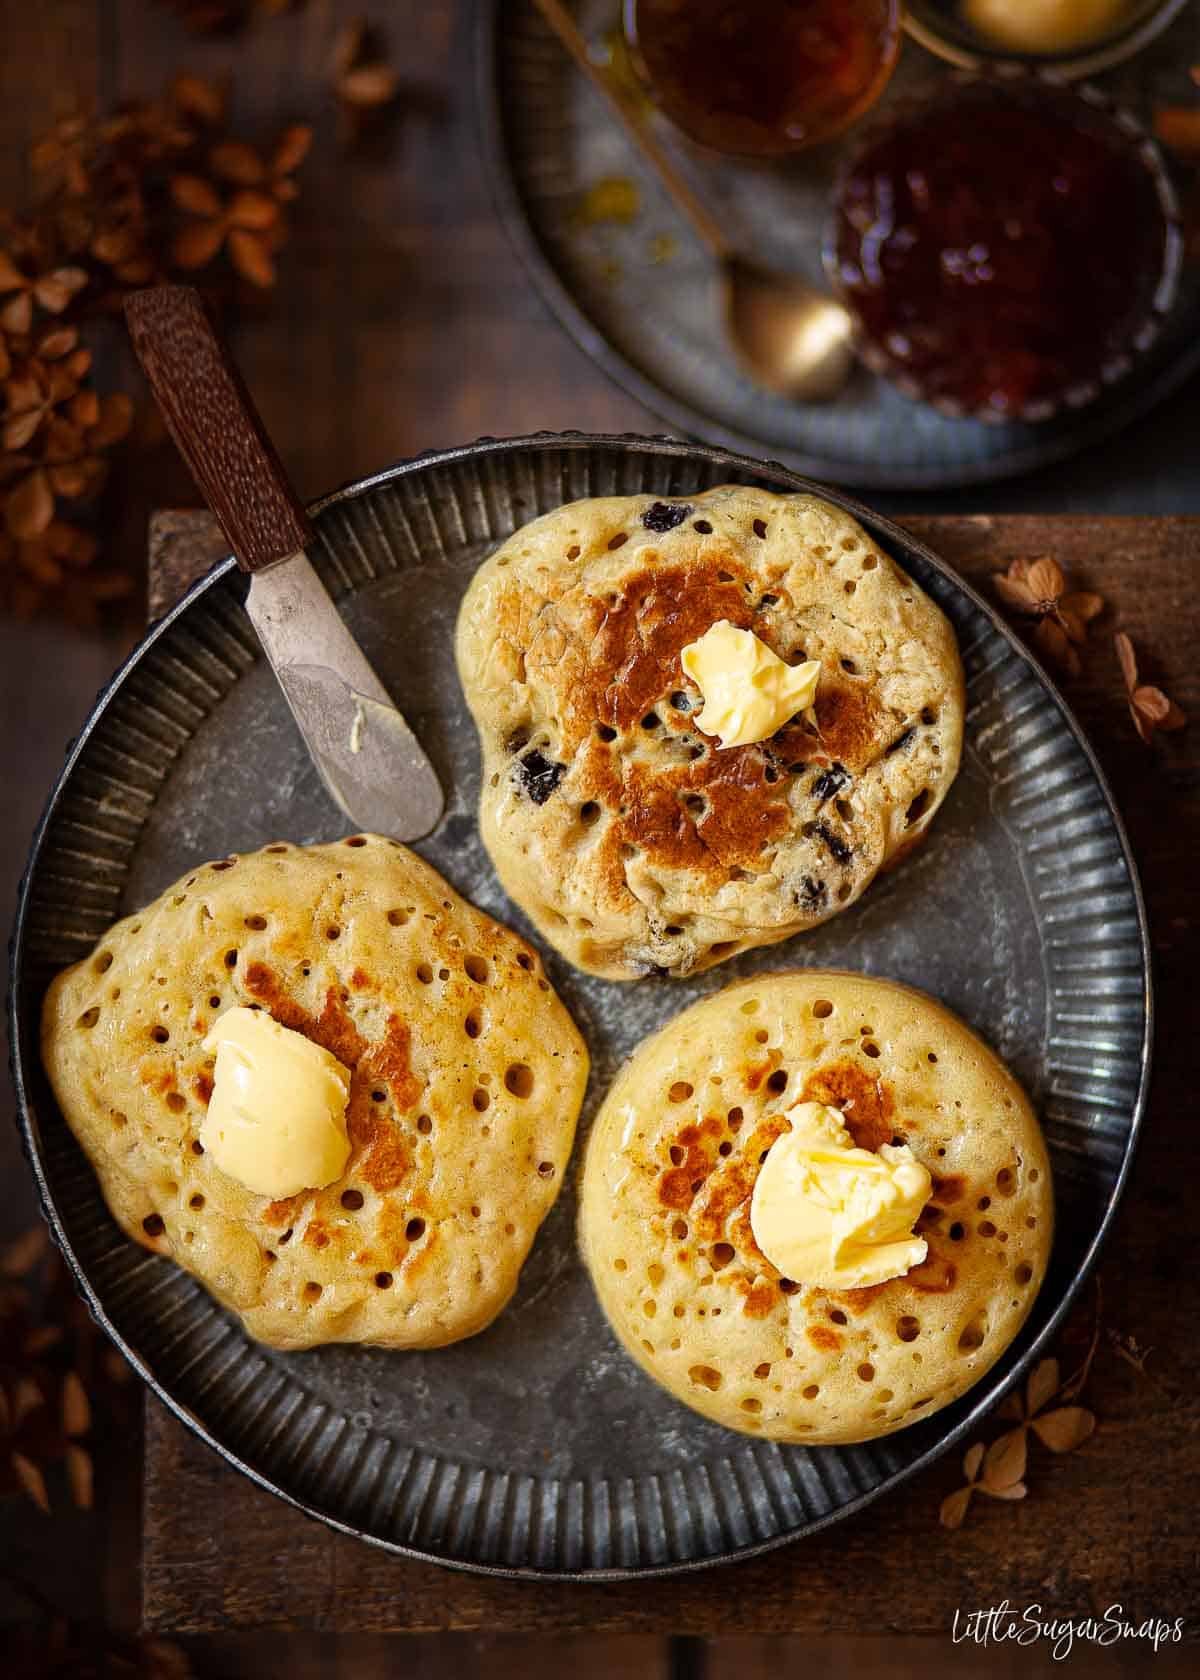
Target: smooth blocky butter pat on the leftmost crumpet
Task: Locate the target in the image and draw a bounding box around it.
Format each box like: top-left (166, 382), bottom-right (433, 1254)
top-left (200, 1008), bottom-right (350, 1200)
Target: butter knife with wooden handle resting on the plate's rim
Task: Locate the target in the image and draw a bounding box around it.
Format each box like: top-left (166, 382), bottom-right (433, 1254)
top-left (124, 286), bottom-right (444, 840)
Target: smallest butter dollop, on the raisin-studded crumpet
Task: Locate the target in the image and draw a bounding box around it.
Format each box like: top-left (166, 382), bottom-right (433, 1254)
top-left (681, 618), bottom-right (820, 746)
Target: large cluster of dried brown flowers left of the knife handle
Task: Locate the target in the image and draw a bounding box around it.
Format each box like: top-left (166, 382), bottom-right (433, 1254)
top-left (0, 72), bottom-right (311, 623)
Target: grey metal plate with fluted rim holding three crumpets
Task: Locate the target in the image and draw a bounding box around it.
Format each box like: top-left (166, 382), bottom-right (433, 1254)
top-left (12, 435), bottom-right (1150, 1579)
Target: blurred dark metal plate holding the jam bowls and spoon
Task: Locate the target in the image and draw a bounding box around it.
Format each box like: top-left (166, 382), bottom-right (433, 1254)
top-left (476, 0), bottom-right (1200, 489)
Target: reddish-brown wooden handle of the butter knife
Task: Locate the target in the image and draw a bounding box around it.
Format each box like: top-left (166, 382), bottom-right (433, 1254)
top-left (124, 286), bottom-right (313, 571)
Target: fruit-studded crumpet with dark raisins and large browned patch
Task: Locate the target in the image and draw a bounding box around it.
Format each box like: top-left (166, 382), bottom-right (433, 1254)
top-left (457, 487), bottom-right (963, 979)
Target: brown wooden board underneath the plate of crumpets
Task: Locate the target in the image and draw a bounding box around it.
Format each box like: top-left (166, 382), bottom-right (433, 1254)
top-left (143, 514), bottom-right (1200, 1626)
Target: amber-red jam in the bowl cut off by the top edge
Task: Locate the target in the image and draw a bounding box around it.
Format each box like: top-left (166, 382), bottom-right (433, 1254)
top-left (627, 0), bottom-right (899, 158)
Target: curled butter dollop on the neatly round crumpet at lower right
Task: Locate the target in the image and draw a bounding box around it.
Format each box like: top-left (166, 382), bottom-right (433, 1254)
top-left (750, 1102), bottom-right (933, 1289)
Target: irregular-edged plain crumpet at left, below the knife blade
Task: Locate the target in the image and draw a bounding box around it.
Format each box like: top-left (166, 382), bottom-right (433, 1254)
top-left (42, 835), bottom-right (588, 1347)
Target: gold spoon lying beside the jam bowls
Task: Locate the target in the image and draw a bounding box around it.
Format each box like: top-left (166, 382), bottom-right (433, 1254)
top-left (534, 0), bottom-right (854, 403)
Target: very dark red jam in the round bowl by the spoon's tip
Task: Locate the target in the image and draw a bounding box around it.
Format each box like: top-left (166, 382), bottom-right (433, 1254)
top-left (834, 82), bottom-right (1168, 418)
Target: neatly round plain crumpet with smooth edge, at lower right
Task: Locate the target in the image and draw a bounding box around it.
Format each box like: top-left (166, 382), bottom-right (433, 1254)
top-left (580, 969), bottom-right (1054, 1445)
